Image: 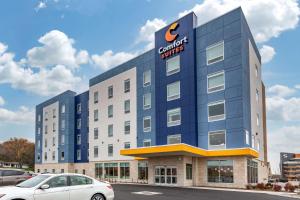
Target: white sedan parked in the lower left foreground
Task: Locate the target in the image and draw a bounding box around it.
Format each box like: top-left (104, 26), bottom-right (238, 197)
top-left (0, 174), bottom-right (114, 200)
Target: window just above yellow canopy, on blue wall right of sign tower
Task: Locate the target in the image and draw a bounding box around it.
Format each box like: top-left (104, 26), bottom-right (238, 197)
top-left (208, 131), bottom-right (226, 149)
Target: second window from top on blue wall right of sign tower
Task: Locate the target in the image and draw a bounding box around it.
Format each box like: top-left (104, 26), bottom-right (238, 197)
top-left (207, 72), bottom-right (225, 93)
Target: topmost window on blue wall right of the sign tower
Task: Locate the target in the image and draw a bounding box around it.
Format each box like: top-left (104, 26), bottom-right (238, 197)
top-left (206, 41), bottom-right (224, 65)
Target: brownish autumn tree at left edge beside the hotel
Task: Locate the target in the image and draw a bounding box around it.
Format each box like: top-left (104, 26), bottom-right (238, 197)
top-left (0, 138), bottom-right (34, 167)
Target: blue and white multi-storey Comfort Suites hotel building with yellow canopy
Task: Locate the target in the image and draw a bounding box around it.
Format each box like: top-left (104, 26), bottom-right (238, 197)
top-left (35, 8), bottom-right (269, 188)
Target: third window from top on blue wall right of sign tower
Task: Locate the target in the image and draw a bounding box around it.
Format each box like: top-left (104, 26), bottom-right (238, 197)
top-left (208, 101), bottom-right (225, 122)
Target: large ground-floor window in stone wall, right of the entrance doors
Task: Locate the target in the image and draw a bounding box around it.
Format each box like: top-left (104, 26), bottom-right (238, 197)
top-left (207, 160), bottom-right (233, 183)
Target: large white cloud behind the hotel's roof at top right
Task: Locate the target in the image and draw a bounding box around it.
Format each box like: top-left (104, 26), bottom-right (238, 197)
top-left (179, 0), bottom-right (300, 42)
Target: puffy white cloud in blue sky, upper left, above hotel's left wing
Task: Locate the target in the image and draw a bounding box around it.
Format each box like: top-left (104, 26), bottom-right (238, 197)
top-left (27, 30), bottom-right (88, 69)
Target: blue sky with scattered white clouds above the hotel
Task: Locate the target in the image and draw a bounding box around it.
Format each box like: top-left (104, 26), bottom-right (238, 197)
top-left (0, 0), bottom-right (300, 171)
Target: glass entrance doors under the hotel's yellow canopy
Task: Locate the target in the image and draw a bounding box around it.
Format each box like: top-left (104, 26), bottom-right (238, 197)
top-left (154, 166), bottom-right (177, 185)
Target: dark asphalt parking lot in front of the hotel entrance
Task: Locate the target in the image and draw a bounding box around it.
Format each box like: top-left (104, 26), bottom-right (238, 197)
top-left (113, 184), bottom-right (293, 200)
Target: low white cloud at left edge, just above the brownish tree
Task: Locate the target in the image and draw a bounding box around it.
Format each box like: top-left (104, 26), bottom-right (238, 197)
top-left (0, 106), bottom-right (35, 125)
